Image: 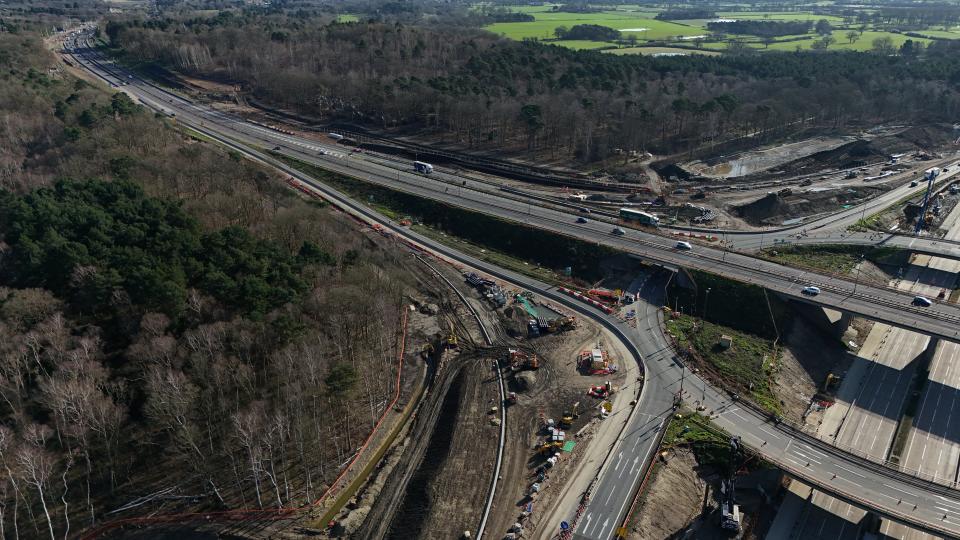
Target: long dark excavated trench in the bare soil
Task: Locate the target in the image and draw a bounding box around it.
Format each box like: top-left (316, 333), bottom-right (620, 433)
top-left (386, 371), bottom-right (465, 540)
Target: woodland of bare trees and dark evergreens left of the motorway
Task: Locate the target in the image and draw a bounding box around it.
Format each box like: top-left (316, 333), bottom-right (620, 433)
top-left (0, 32), bottom-right (415, 540)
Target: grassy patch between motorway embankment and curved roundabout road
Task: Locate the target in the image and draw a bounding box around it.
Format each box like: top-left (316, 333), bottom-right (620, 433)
top-left (667, 315), bottom-right (781, 414)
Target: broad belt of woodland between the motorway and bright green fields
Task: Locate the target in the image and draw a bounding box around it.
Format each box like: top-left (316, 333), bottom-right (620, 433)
top-left (106, 13), bottom-right (960, 161)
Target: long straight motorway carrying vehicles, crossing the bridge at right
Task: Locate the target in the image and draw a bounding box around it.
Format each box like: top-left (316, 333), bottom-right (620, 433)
top-left (58, 45), bottom-right (960, 341)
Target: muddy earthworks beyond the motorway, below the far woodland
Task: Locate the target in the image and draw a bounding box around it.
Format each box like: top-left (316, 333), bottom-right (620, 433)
top-left (488, 126), bottom-right (957, 231)
